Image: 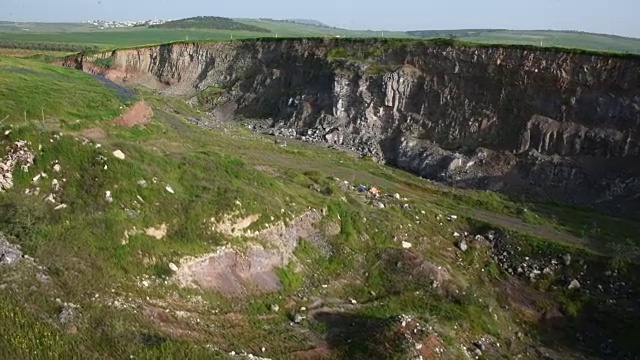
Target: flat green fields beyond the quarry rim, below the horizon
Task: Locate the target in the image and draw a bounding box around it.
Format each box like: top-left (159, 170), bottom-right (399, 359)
top-left (0, 19), bottom-right (640, 54)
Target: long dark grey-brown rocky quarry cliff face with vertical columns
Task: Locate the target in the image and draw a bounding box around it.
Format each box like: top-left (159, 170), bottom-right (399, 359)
top-left (66, 39), bottom-right (640, 211)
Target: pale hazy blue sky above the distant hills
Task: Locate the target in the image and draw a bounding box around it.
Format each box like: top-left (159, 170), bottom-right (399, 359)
top-left (0, 0), bottom-right (640, 37)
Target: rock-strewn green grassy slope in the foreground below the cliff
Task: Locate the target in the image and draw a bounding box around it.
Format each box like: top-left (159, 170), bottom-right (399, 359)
top-left (0, 55), bottom-right (638, 359)
